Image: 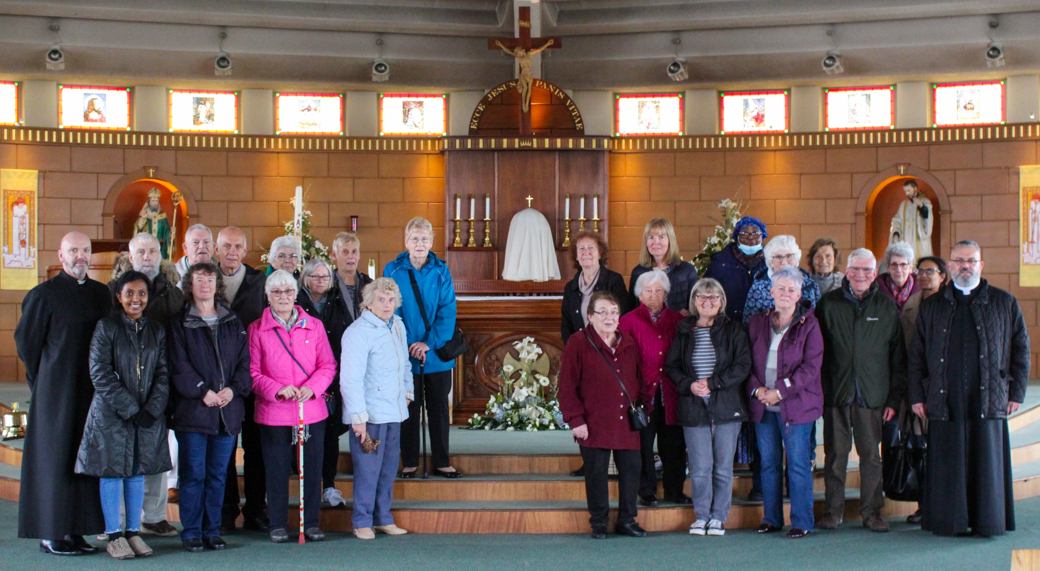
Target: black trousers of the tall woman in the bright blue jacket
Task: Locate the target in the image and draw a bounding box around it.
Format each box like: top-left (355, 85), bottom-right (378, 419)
top-left (400, 369), bottom-right (451, 468)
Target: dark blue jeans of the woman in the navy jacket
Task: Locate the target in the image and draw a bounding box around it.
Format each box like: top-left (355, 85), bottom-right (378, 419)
top-left (177, 431), bottom-right (238, 541)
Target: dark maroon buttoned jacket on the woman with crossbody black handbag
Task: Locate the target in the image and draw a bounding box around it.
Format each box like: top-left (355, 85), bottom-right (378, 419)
top-left (557, 328), bottom-right (649, 450)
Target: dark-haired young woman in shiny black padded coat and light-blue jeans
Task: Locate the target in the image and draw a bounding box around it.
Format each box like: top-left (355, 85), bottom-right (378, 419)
top-left (75, 271), bottom-right (170, 560)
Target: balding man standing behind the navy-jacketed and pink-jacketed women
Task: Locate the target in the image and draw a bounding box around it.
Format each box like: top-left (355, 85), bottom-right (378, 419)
top-left (216, 226), bottom-right (267, 535)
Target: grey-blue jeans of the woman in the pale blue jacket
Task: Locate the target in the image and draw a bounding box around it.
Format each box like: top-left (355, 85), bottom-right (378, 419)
top-left (350, 422), bottom-right (400, 529)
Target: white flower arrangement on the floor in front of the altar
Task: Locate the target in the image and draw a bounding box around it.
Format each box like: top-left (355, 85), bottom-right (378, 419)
top-left (468, 337), bottom-right (568, 433)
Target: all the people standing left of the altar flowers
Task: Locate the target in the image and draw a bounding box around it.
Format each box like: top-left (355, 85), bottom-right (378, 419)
top-left (15, 217), bottom-right (462, 560)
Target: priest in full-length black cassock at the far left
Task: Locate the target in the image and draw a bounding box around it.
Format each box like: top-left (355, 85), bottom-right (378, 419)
top-left (15, 232), bottom-right (111, 555)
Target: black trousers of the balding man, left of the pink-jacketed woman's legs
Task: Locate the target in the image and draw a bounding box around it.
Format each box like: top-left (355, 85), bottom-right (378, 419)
top-left (223, 394), bottom-right (267, 521)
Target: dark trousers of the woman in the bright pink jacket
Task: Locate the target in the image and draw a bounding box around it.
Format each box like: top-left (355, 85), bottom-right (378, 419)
top-left (260, 420), bottom-right (324, 529)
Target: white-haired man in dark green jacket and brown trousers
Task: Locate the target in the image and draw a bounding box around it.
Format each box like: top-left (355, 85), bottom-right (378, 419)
top-left (816, 248), bottom-right (907, 531)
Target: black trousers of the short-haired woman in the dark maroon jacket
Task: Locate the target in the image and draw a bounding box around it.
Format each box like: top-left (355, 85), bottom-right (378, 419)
top-left (578, 445), bottom-right (641, 527)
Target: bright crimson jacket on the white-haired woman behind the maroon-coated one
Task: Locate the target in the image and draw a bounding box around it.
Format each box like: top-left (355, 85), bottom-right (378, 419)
top-left (618, 304), bottom-right (682, 424)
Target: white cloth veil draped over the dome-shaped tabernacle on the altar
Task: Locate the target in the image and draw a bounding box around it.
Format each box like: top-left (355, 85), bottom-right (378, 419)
top-left (502, 208), bottom-right (560, 282)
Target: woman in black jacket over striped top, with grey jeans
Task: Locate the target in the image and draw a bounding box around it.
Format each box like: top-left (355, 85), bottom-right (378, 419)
top-left (665, 279), bottom-right (751, 536)
